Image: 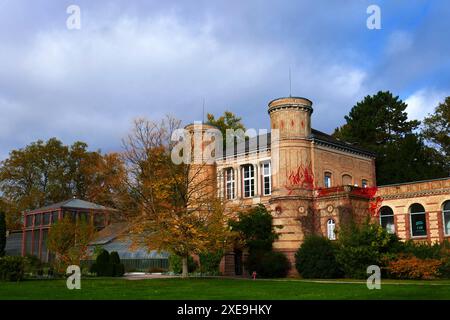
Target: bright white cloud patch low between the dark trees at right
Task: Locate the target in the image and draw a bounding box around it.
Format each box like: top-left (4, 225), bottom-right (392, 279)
top-left (405, 89), bottom-right (450, 120)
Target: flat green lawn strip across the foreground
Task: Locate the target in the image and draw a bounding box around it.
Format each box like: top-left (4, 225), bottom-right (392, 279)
top-left (0, 278), bottom-right (450, 300)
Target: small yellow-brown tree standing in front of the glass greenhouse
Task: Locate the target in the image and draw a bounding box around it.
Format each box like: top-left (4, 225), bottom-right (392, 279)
top-left (47, 216), bottom-right (95, 270)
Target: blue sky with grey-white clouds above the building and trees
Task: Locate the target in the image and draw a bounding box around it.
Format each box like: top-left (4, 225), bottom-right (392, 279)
top-left (0, 0), bottom-right (450, 159)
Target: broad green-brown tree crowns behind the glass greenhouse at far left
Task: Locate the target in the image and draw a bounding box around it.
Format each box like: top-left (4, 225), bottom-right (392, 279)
top-left (0, 138), bottom-right (125, 229)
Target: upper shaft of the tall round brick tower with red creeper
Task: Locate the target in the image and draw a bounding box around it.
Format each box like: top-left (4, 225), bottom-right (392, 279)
top-left (268, 97), bottom-right (313, 196)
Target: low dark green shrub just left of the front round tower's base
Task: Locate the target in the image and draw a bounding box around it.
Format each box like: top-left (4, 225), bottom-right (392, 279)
top-left (246, 251), bottom-right (290, 278)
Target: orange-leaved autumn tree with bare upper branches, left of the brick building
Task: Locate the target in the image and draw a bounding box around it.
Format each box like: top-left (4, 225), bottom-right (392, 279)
top-left (124, 117), bottom-right (236, 277)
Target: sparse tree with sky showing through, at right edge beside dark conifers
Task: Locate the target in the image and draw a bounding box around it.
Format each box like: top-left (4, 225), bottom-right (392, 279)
top-left (422, 97), bottom-right (450, 163)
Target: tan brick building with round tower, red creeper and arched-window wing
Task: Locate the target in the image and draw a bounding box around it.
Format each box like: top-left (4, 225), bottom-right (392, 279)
top-left (186, 97), bottom-right (450, 275)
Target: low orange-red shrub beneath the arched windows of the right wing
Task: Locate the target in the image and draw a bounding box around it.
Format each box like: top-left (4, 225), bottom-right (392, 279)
top-left (388, 257), bottom-right (442, 279)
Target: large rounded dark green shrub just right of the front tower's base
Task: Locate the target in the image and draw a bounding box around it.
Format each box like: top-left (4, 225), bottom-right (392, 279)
top-left (295, 235), bottom-right (342, 279)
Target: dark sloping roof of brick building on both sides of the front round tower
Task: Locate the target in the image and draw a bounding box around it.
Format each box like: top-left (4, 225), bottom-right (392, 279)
top-left (223, 129), bottom-right (375, 157)
